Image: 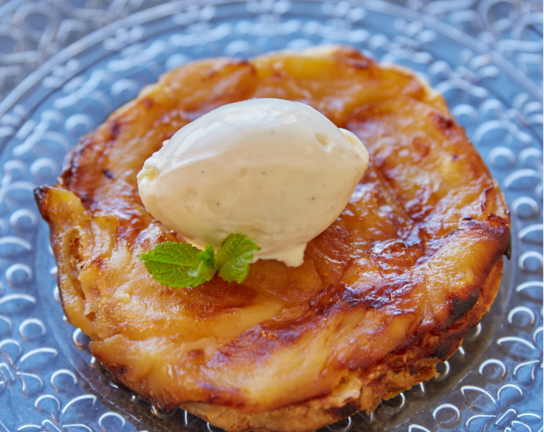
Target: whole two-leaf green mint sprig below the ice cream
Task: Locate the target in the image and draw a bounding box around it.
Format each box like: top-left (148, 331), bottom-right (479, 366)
top-left (138, 233), bottom-right (259, 288)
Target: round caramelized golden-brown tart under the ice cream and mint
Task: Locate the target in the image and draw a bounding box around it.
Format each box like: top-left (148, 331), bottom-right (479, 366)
top-left (36, 47), bottom-right (510, 432)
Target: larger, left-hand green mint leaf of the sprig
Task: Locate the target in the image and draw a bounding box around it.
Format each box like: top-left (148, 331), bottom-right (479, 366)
top-left (138, 242), bottom-right (217, 288)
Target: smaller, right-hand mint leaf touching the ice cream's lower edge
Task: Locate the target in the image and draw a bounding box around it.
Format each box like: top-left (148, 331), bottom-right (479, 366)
top-left (215, 234), bottom-right (260, 283)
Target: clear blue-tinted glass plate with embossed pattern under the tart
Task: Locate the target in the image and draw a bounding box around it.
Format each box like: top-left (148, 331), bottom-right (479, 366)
top-left (0, 0), bottom-right (543, 432)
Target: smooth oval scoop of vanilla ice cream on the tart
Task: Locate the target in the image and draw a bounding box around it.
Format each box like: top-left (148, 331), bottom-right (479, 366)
top-left (138, 99), bottom-right (368, 266)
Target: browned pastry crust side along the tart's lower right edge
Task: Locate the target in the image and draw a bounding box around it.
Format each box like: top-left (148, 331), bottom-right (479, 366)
top-left (181, 261), bottom-right (502, 432)
